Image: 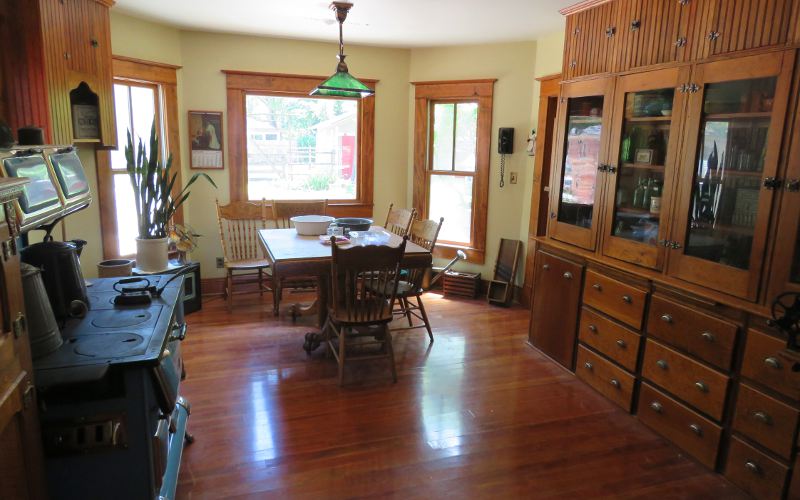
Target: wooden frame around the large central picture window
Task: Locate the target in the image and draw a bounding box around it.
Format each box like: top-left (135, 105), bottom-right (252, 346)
top-left (222, 70), bottom-right (378, 217)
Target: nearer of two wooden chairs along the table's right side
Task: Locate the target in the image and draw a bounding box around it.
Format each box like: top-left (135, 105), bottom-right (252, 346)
top-left (394, 217), bottom-right (444, 342)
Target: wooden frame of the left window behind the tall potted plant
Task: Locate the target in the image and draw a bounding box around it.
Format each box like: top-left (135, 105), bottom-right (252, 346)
top-left (95, 56), bottom-right (183, 259)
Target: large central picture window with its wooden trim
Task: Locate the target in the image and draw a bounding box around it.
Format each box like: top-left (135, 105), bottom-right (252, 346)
top-left (225, 71), bottom-right (376, 216)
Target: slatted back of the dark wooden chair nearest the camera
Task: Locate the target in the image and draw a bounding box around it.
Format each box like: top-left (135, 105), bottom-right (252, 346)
top-left (331, 238), bottom-right (406, 323)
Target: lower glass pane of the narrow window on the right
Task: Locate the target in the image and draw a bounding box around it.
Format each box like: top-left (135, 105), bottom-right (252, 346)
top-left (428, 174), bottom-right (473, 244)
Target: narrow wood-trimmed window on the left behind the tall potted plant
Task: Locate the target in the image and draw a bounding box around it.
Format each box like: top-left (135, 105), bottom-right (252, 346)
top-left (97, 57), bottom-right (182, 259)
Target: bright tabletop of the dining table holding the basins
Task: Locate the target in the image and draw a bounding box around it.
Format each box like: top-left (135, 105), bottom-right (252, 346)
top-left (259, 226), bottom-right (430, 262)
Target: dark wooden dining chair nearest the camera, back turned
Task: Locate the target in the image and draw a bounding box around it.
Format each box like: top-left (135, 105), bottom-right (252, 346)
top-left (324, 238), bottom-right (406, 385)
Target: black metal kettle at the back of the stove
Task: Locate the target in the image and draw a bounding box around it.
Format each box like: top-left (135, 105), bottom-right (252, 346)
top-left (20, 240), bottom-right (89, 322)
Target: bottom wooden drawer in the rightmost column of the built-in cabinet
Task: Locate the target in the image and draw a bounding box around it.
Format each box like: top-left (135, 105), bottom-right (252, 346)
top-left (725, 438), bottom-right (789, 500)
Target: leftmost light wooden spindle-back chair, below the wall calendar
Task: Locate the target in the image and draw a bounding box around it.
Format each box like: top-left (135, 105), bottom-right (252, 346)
top-left (216, 200), bottom-right (270, 311)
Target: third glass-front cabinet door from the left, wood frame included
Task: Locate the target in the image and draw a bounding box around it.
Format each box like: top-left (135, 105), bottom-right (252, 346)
top-left (668, 52), bottom-right (793, 300)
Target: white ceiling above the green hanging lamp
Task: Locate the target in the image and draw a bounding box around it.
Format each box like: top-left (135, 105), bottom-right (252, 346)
top-left (114, 0), bottom-right (576, 47)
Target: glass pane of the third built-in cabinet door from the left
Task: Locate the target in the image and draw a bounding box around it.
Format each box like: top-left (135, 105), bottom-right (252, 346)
top-left (686, 78), bottom-right (776, 269)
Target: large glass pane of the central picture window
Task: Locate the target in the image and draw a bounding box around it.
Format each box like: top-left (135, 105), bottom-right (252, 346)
top-left (245, 95), bottom-right (358, 200)
